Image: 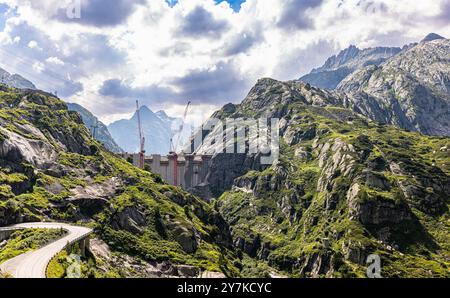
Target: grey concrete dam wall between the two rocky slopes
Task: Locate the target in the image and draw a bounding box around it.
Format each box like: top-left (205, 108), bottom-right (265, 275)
top-left (121, 153), bottom-right (212, 190)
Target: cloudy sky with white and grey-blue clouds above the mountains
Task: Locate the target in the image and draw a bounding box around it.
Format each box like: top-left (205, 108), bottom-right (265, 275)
top-left (0, 0), bottom-right (450, 125)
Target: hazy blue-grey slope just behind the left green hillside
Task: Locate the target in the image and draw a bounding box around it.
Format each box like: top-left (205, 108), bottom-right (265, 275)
top-left (67, 103), bottom-right (123, 153)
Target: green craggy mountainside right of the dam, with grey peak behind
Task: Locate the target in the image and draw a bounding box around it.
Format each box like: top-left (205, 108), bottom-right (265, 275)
top-left (185, 36), bottom-right (450, 277)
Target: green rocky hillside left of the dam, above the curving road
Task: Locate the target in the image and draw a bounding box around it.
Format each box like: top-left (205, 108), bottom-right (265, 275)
top-left (0, 87), bottom-right (238, 276)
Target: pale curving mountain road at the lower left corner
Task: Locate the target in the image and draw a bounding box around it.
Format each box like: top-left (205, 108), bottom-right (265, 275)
top-left (0, 222), bottom-right (92, 278)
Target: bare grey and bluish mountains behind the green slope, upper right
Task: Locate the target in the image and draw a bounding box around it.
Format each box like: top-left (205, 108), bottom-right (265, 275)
top-left (300, 33), bottom-right (450, 136)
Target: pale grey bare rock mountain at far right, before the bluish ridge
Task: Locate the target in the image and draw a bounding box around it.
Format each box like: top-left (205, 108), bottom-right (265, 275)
top-left (338, 39), bottom-right (450, 136)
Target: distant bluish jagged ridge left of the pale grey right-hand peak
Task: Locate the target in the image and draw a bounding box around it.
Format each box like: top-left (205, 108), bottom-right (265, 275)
top-left (300, 45), bottom-right (402, 90)
